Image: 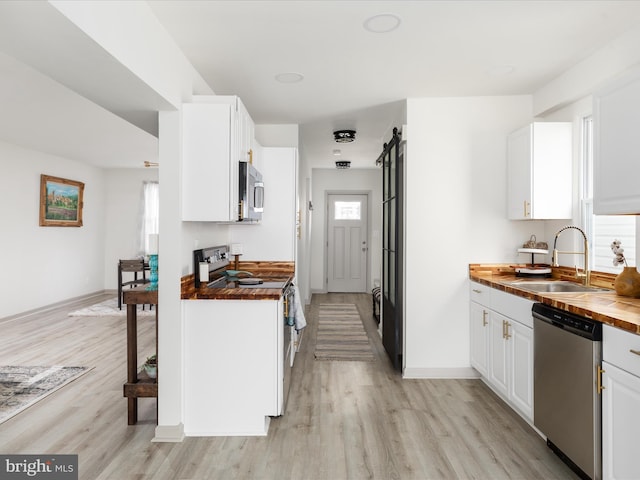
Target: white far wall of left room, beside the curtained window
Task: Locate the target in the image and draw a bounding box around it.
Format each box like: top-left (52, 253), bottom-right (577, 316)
top-left (104, 168), bottom-right (158, 290)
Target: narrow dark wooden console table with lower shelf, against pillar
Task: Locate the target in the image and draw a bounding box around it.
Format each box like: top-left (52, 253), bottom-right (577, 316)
top-left (123, 287), bottom-right (158, 425)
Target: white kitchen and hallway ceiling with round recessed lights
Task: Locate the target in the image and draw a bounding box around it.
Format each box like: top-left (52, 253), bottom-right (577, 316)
top-left (149, 0), bottom-right (640, 167)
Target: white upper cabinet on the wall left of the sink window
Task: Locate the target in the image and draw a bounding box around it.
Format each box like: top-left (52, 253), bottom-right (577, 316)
top-left (507, 122), bottom-right (572, 220)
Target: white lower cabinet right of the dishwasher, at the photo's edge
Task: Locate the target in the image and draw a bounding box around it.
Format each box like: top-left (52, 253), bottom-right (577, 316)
top-left (602, 325), bottom-right (640, 480)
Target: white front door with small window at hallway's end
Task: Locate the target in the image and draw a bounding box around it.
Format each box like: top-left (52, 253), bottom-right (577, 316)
top-left (327, 194), bottom-right (369, 292)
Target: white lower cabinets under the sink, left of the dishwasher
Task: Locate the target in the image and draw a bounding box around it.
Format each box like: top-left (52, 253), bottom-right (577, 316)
top-left (470, 282), bottom-right (533, 421)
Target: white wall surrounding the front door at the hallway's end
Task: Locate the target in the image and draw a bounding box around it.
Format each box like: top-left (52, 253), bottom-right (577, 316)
top-left (309, 168), bottom-right (382, 292)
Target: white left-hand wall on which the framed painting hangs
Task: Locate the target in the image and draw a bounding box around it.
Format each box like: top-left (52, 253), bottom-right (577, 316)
top-left (0, 142), bottom-right (105, 318)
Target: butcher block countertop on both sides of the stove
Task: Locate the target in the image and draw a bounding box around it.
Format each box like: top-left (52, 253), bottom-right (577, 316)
top-left (180, 262), bottom-right (294, 300)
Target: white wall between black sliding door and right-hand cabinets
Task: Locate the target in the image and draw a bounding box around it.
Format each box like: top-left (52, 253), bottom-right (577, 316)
top-left (404, 96), bottom-right (544, 377)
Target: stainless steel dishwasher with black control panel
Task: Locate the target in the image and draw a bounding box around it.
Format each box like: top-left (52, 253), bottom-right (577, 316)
top-left (532, 303), bottom-right (602, 480)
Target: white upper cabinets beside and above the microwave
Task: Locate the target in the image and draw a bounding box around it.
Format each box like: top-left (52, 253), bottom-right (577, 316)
top-left (182, 96), bottom-right (254, 222)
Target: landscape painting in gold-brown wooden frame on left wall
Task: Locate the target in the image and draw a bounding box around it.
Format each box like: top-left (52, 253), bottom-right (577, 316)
top-left (40, 174), bottom-right (84, 227)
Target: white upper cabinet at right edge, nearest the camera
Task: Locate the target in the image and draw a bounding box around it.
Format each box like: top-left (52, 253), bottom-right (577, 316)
top-left (593, 68), bottom-right (640, 215)
